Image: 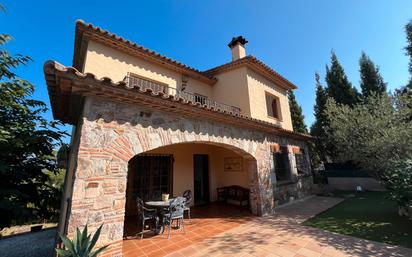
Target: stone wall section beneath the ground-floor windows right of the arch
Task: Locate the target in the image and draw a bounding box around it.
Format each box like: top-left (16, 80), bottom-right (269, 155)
top-left (273, 175), bottom-right (313, 206)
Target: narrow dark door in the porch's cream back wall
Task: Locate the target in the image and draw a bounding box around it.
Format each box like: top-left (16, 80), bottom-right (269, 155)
top-left (193, 154), bottom-right (209, 205)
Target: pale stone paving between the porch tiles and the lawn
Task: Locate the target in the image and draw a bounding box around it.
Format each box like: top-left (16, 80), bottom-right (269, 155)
top-left (168, 196), bottom-right (412, 257)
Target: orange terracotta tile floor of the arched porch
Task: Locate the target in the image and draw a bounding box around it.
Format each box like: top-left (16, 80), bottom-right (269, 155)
top-left (122, 203), bottom-right (255, 257)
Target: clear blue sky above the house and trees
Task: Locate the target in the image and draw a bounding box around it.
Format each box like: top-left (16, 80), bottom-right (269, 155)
top-left (0, 0), bottom-right (412, 138)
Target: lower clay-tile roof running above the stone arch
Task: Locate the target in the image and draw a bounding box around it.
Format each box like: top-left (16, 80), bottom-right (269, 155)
top-left (44, 61), bottom-right (311, 140)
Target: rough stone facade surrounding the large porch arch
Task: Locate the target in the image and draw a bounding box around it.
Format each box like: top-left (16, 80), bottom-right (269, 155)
top-left (67, 97), bottom-right (307, 253)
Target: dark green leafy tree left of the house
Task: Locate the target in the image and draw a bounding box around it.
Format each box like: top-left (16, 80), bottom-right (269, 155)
top-left (0, 31), bottom-right (64, 228)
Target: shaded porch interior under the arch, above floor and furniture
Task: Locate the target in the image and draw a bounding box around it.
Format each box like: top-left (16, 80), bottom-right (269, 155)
top-left (124, 142), bottom-right (256, 236)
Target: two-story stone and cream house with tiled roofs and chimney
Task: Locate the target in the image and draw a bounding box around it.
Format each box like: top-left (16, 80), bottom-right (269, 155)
top-left (44, 21), bottom-right (312, 254)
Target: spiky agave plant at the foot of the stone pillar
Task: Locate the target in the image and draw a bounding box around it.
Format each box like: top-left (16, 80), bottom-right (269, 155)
top-left (56, 224), bottom-right (108, 257)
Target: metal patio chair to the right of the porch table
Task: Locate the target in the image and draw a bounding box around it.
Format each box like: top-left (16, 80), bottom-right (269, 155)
top-left (163, 196), bottom-right (186, 239)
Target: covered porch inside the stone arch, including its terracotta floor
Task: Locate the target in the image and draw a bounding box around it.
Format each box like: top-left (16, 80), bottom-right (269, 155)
top-left (117, 142), bottom-right (256, 256)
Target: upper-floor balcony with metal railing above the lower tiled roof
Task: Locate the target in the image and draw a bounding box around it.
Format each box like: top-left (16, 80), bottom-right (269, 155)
top-left (124, 76), bottom-right (241, 115)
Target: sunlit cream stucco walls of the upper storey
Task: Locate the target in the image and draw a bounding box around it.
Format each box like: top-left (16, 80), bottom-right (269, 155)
top-left (84, 41), bottom-right (292, 130)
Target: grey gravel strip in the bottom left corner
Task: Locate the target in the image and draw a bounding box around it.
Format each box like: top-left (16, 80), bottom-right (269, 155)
top-left (0, 229), bottom-right (57, 257)
